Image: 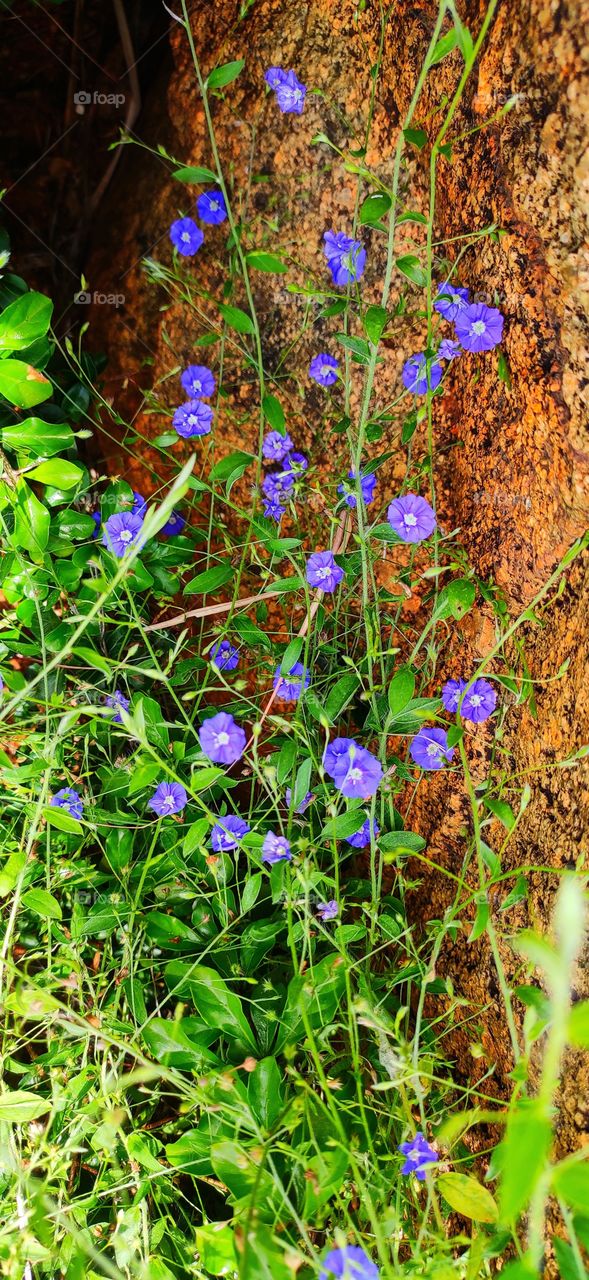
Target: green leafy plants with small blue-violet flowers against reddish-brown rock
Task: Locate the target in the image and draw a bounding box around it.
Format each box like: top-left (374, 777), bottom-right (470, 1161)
top-left (0, 0), bottom-right (589, 1280)
